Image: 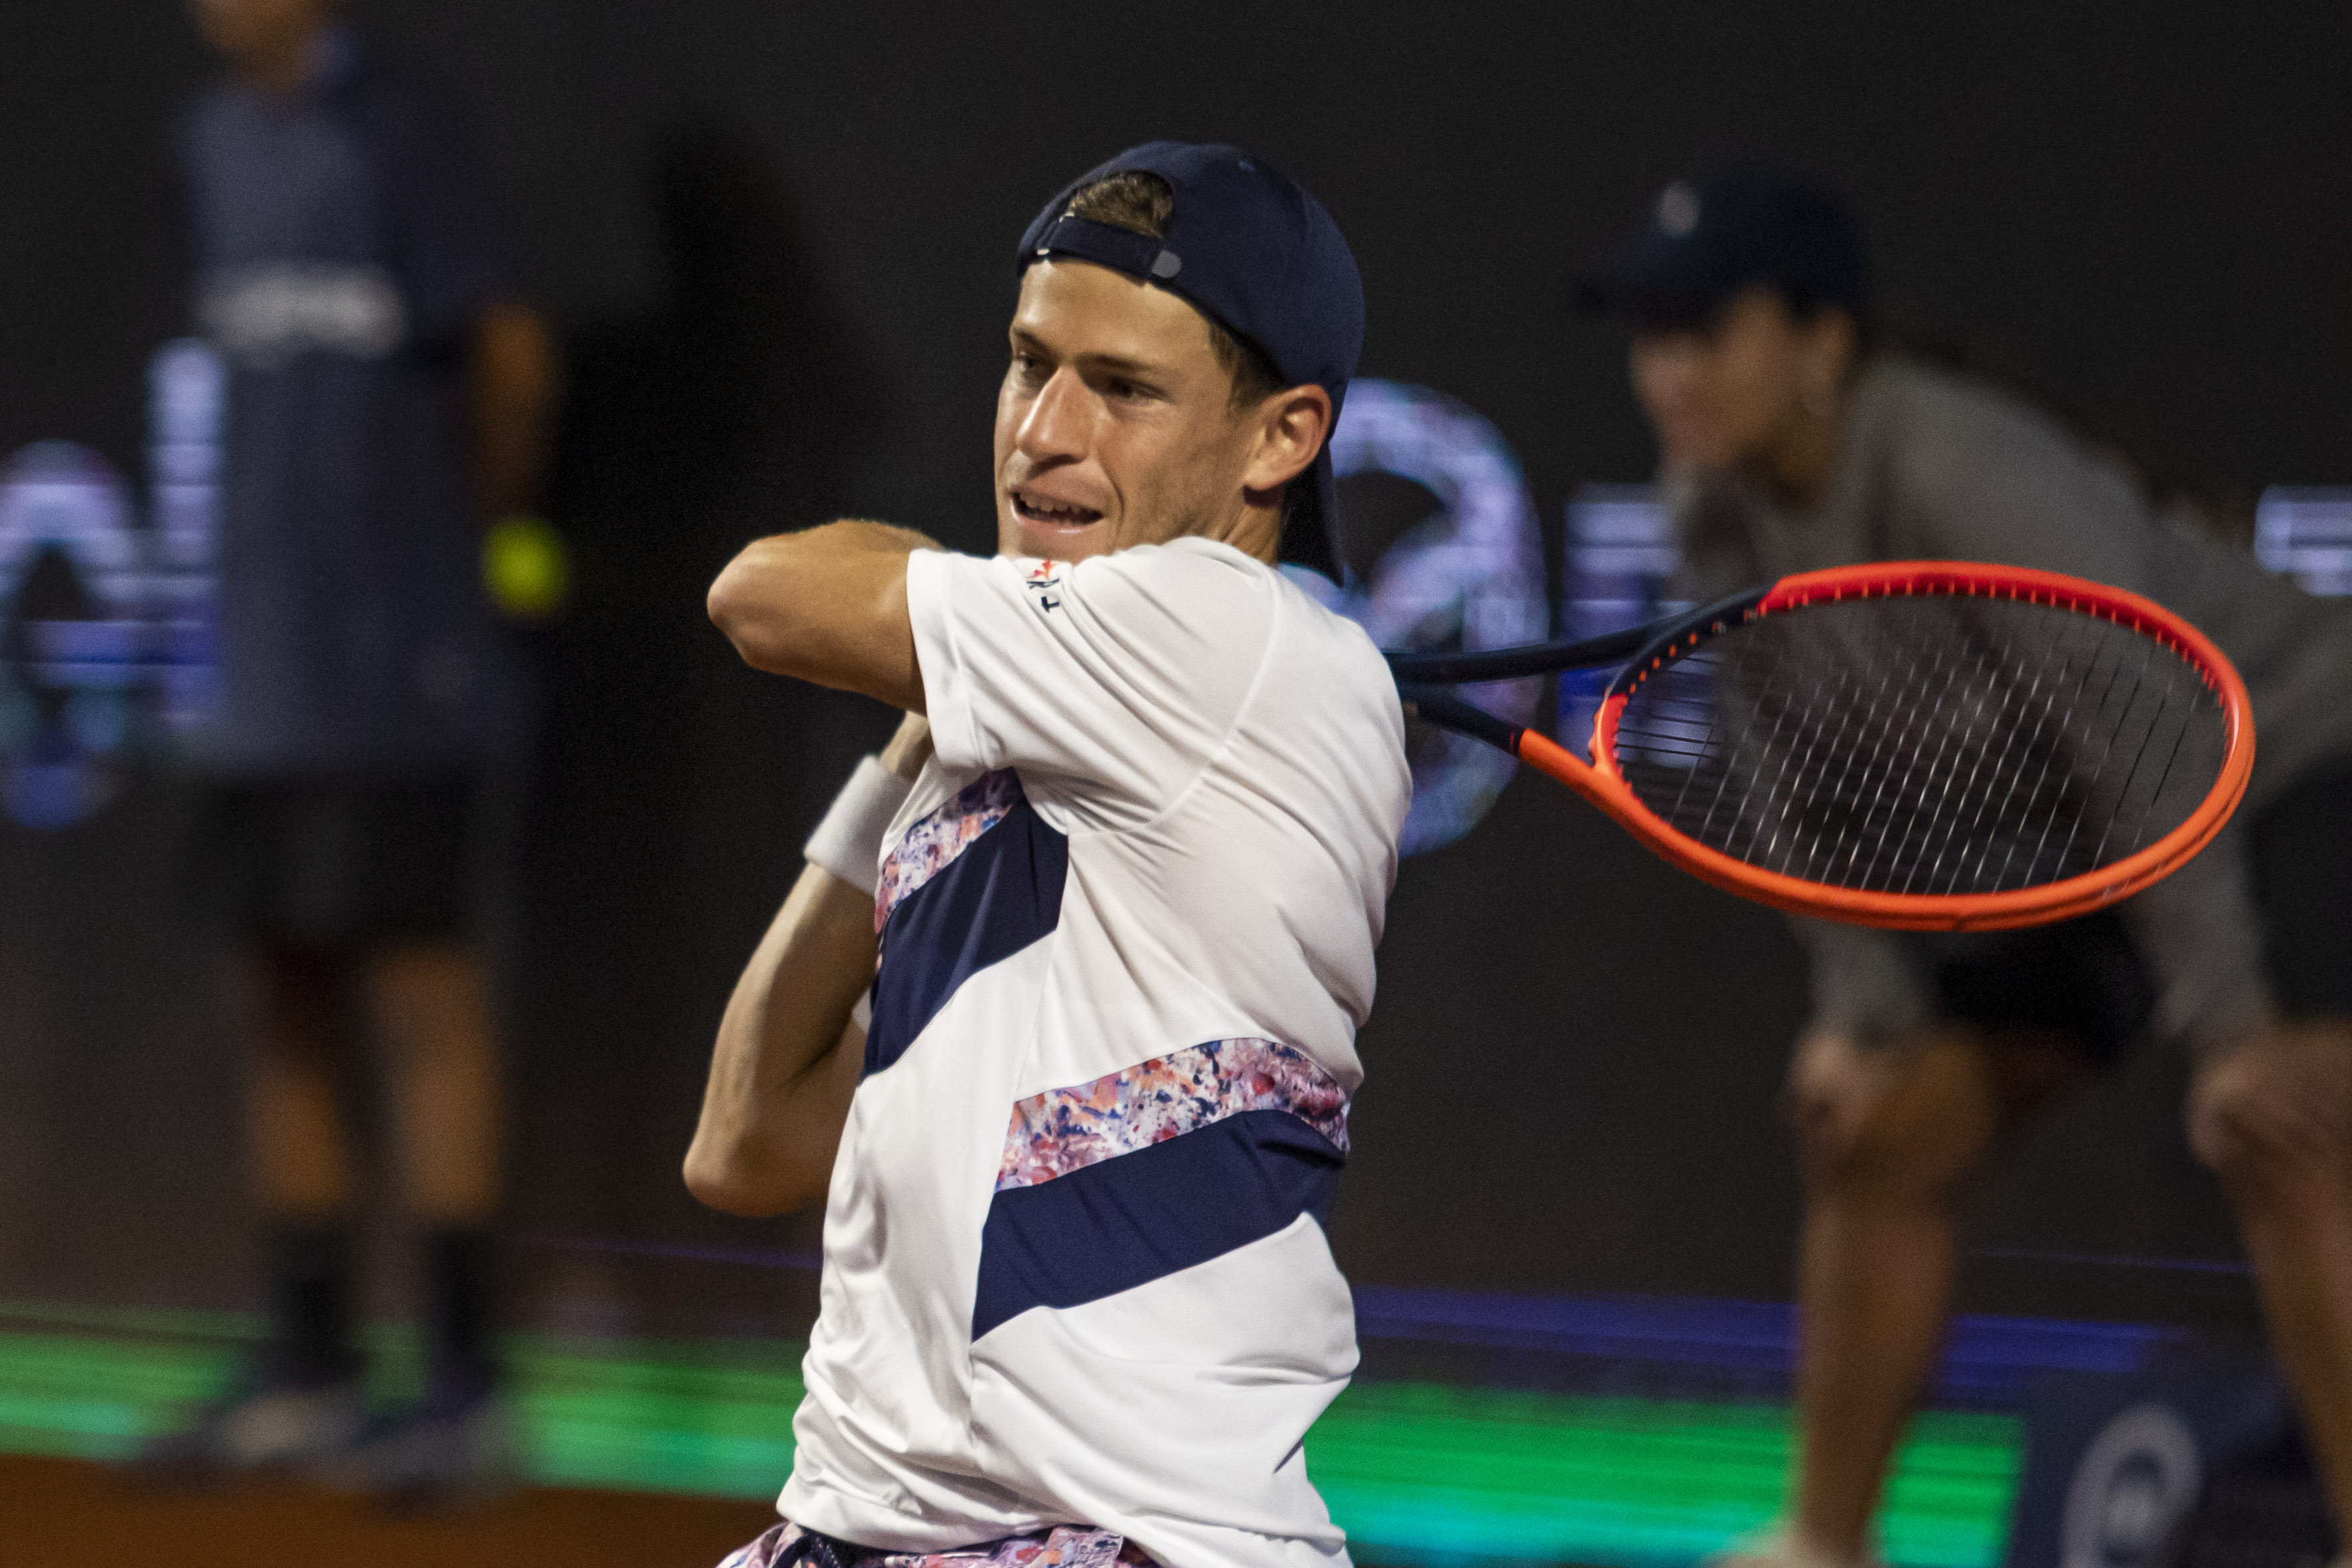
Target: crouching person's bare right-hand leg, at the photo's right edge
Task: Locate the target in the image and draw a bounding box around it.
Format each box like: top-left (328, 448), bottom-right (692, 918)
top-left (2189, 1018), bottom-right (2352, 1530)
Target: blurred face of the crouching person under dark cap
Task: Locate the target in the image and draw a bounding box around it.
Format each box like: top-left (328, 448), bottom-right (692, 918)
top-left (1633, 289), bottom-right (1851, 468)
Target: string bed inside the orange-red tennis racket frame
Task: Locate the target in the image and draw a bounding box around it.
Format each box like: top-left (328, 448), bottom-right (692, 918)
top-left (1616, 595), bottom-right (2227, 896)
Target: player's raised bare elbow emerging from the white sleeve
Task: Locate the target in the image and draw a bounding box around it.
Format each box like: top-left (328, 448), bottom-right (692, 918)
top-left (710, 522), bottom-right (938, 712)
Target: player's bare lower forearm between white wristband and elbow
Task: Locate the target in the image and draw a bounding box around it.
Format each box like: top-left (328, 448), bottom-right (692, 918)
top-left (687, 865), bottom-right (875, 1216)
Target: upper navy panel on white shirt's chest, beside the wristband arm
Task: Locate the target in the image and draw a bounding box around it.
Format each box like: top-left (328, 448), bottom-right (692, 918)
top-left (865, 797), bottom-right (1070, 1072)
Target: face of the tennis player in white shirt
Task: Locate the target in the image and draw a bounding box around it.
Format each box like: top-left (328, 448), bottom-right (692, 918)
top-left (995, 261), bottom-right (1254, 562)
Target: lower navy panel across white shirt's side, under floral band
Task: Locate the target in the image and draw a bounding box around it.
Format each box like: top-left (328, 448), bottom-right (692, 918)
top-left (972, 1109), bottom-right (1345, 1340)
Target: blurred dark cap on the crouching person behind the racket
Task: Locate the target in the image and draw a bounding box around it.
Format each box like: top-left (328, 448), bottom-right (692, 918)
top-left (1578, 165), bottom-right (1870, 329)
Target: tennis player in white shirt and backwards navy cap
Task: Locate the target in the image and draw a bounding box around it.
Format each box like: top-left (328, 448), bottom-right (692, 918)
top-left (687, 141), bottom-right (1411, 1568)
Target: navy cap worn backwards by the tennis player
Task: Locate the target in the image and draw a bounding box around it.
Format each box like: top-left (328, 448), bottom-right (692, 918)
top-left (1013, 141), bottom-right (1364, 581)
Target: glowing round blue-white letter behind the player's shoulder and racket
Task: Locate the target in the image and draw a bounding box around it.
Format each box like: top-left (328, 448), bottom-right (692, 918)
top-left (1291, 378), bottom-right (1550, 856)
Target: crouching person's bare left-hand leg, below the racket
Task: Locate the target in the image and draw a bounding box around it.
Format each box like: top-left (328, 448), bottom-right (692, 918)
top-left (1790, 1032), bottom-right (2070, 1561)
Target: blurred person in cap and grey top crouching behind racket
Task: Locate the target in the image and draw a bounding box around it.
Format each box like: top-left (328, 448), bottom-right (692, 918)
top-left (1585, 167), bottom-right (2352, 1565)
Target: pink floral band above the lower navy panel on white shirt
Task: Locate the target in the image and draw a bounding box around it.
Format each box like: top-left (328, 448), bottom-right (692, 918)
top-left (997, 1039), bottom-right (1348, 1192)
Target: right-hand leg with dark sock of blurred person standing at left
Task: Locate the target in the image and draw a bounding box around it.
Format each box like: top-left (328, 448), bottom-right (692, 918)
top-left (367, 940), bottom-right (506, 1406)
